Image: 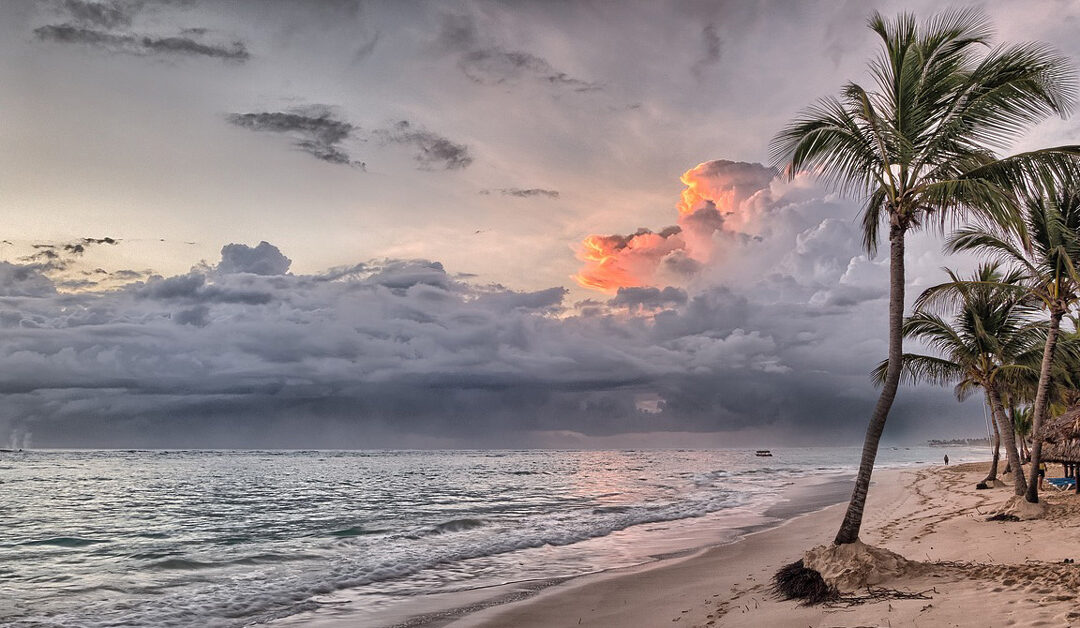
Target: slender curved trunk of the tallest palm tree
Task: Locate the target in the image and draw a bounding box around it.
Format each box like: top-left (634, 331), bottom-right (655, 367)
top-left (833, 222), bottom-right (907, 545)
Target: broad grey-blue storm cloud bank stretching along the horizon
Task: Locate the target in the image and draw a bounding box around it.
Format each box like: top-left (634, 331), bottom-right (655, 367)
top-left (0, 162), bottom-right (977, 446)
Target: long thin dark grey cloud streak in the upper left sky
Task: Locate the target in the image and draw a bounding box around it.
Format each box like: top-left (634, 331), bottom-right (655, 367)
top-left (33, 24), bottom-right (251, 62)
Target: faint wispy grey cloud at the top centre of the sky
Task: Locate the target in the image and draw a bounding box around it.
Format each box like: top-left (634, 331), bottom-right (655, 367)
top-left (435, 14), bottom-right (600, 92)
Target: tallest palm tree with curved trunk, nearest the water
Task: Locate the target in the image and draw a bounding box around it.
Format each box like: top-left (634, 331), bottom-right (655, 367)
top-left (772, 10), bottom-right (1080, 545)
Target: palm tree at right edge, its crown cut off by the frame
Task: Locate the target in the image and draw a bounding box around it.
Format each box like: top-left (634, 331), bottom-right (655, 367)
top-left (947, 188), bottom-right (1080, 504)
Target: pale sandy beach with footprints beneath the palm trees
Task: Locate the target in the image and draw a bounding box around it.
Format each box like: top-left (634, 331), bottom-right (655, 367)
top-left (450, 464), bottom-right (1080, 628)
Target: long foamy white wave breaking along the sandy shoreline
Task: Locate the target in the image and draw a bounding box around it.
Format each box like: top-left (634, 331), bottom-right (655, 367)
top-left (38, 492), bottom-right (750, 627)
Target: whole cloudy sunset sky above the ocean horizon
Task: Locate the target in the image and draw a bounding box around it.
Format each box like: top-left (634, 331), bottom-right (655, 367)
top-left (0, 0), bottom-right (1080, 447)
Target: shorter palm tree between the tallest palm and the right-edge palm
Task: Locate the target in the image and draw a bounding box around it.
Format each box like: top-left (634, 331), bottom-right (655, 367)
top-left (874, 264), bottom-right (1045, 495)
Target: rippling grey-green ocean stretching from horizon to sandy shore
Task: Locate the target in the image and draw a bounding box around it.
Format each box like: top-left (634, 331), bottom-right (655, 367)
top-left (0, 447), bottom-right (988, 628)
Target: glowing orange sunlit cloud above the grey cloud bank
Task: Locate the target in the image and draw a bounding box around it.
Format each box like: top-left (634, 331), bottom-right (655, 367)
top-left (572, 160), bottom-right (775, 293)
